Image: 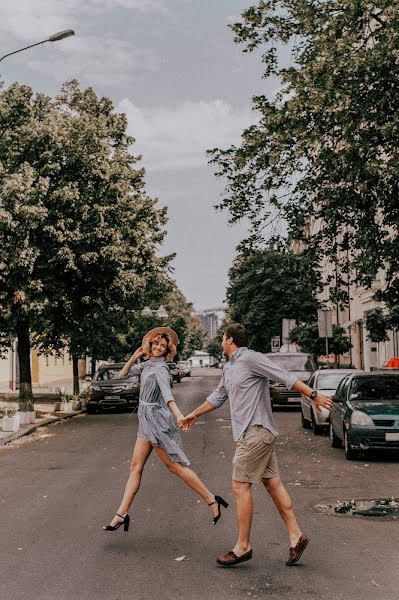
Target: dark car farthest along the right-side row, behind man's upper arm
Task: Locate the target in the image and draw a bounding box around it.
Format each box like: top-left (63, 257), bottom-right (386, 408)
top-left (266, 352), bottom-right (316, 406)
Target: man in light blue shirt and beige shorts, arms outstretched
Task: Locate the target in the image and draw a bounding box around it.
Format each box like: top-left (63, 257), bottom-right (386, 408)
top-left (183, 323), bottom-right (332, 566)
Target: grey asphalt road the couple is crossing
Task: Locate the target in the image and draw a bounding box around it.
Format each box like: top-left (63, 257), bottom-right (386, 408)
top-left (0, 370), bottom-right (399, 600)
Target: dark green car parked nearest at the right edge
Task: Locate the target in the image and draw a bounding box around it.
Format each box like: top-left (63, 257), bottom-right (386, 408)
top-left (330, 372), bottom-right (399, 460)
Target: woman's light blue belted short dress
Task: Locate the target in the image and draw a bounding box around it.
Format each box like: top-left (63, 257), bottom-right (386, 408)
top-left (126, 356), bottom-right (190, 466)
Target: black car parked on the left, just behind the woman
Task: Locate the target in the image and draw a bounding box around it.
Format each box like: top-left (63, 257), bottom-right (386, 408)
top-left (86, 363), bottom-right (140, 413)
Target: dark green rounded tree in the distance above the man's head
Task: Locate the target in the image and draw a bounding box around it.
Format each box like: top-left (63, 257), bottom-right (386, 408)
top-left (227, 248), bottom-right (318, 352)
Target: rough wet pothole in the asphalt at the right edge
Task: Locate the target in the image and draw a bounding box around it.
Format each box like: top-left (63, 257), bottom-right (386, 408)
top-left (314, 498), bottom-right (399, 520)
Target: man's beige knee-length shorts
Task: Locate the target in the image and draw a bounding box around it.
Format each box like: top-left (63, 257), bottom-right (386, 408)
top-left (233, 425), bottom-right (279, 483)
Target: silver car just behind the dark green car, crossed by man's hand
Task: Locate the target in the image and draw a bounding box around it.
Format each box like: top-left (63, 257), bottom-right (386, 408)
top-left (301, 369), bottom-right (359, 435)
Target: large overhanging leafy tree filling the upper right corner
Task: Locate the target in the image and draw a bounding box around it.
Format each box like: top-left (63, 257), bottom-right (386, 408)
top-left (211, 0), bottom-right (399, 316)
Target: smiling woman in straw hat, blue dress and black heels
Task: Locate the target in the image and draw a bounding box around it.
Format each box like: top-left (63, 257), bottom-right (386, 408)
top-left (103, 327), bottom-right (228, 531)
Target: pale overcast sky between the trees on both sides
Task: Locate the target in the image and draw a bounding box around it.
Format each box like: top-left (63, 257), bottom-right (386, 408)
top-left (0, 0), bottom-right (277, 309)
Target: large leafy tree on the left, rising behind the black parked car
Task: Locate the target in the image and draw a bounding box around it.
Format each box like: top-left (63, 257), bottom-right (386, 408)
top-left (34, 81), bottom-right (170, 392)
